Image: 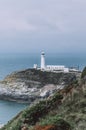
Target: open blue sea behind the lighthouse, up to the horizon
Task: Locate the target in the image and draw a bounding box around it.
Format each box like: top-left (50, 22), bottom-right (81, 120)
top-left (0, 53), bottom-right (86, 80)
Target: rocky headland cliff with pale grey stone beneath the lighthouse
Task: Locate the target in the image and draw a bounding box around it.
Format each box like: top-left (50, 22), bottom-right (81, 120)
top-left (0, 69), bottom-right (79, 103)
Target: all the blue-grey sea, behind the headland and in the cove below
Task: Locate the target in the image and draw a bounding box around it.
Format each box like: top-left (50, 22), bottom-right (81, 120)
top-left (0, 53), bottom-right (86, 125)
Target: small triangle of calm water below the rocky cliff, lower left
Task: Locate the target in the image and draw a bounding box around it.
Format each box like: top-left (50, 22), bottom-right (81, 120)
top-left (0, 100), bottom-right (28, 125)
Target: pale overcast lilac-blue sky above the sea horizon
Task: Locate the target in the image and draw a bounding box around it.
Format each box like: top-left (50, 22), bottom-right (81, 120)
top-left (0, 0), bottom-right (86, 53)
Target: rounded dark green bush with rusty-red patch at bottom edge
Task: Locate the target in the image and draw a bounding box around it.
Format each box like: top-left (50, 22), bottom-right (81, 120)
top-left (33, 115), bottom-right (71, 130)
